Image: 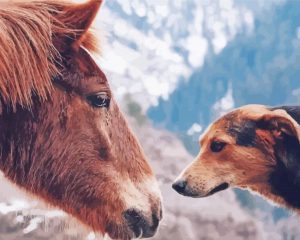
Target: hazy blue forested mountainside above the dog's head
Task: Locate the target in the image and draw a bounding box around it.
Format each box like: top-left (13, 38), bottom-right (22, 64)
top-left (148, 1), bottom-right (300, 132)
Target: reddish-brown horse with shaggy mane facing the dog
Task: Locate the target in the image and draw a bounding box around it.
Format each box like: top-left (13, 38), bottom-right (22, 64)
top-left (0, 0), bottom-right (162, 239)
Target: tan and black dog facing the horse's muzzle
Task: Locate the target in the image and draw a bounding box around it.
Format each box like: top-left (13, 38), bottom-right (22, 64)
top-left (173, 105), bottom-right (300, 212)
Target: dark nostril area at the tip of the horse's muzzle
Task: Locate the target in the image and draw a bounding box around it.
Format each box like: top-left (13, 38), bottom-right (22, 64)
top-left (124, 209), bottom-right (161, 238)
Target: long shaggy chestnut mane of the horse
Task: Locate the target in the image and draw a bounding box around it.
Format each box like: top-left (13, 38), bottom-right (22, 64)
top-left (0, 0), bottom-right (97, 109)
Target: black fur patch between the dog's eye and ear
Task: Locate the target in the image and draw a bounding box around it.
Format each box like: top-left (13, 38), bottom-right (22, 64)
top-left (228, 120), bottom-right (256, 147)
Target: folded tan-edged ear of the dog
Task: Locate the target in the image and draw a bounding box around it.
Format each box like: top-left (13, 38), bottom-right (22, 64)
top-left (257, 109), bottom-right (300, 142)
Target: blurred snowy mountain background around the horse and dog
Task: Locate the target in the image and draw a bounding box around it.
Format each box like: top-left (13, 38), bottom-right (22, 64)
top-left (0, 0), bottom-right (300, 240)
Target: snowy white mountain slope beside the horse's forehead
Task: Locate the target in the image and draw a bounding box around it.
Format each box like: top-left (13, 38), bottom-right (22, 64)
top-left (95, 0), bottom-right (256, 110)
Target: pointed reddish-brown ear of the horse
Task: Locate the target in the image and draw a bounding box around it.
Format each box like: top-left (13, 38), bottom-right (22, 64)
top-left (56, 0), bottom-right (103, 50)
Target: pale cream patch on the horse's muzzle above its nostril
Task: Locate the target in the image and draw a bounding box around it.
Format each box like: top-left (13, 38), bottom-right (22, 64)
top-left (120, 178), bottom-right (161, 214)
